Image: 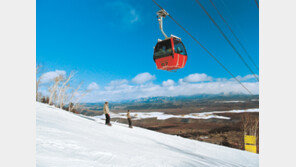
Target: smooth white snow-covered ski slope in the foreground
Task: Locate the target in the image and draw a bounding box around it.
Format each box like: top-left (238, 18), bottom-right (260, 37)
top-left (36, 103), bottom-right (259, 167)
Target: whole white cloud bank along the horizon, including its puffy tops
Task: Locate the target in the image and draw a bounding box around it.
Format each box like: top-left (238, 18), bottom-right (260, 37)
top-left (80, 73), bottom-right (259, 102)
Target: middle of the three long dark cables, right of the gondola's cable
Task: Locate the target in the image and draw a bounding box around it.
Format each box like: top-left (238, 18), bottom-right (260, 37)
top-left (195, 0), bottom-right (259, 81)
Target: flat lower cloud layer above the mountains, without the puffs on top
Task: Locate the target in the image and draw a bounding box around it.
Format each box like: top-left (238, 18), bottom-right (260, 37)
top-left (81, 81), bottom-right (259, 102)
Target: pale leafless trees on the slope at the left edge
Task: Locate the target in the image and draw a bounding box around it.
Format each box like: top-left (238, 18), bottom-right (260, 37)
top-left (36, 66), bottom-right (89, 113)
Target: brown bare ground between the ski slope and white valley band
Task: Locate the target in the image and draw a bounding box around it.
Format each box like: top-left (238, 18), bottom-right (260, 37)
top-left (112, 112), bottom-right (259, 150)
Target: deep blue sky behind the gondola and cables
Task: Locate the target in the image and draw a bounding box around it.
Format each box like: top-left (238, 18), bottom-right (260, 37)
top-left (36, 0), bottom-right (259, 101)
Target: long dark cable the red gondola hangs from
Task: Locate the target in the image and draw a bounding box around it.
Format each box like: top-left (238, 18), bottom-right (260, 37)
top-left (152, 0), bottom-right (253, 95)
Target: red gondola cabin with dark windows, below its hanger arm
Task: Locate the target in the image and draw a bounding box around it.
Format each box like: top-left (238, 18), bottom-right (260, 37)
top-left (153, 35), bottom-right (187, 71)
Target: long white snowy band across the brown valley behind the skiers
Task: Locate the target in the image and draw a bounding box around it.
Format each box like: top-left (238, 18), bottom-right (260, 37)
top-left (94, 108), bottom-right (259, 120)
